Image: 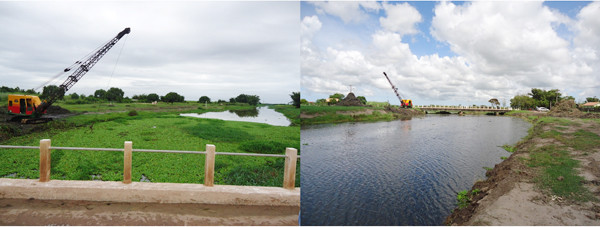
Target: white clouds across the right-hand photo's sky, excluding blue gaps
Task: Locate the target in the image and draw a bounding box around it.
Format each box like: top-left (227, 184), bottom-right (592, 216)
top-left (302, 2), bottom-right (600, 105)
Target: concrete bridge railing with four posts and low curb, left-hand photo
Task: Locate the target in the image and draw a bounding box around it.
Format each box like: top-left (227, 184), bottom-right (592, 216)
top-left (0, 139), bottom-right (300, 207)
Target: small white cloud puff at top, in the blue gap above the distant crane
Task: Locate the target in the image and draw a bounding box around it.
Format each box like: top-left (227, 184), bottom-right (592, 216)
top-left (379, 2), bottom-right (423, 36)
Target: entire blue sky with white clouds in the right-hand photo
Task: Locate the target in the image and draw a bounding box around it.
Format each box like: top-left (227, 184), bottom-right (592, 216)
top-left (300, 1), bottom-right (600, 105)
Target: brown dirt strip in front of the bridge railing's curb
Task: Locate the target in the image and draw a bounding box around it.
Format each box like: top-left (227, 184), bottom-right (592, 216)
top-left (0, 199), bottom-right (299, 225)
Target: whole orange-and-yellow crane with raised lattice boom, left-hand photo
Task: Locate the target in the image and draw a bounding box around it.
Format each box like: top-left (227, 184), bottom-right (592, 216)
top-left (8, 28), bottom-right (131, 124)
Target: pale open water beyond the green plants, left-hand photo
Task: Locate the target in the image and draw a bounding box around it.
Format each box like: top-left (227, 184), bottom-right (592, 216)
top-left (179, 106), bottom-right (291, 126)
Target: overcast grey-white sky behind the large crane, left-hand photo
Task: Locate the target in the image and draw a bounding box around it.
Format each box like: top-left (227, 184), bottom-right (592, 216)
top-left (0, 1), bottom-right (301, 103)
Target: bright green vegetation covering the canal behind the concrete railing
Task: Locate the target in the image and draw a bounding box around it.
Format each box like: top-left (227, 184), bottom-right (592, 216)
top-left (0, 103), bottom-right (300, 187)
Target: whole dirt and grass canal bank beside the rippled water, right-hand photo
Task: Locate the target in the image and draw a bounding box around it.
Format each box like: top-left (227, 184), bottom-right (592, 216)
top-left (444, 114), bottom-right (600, 225)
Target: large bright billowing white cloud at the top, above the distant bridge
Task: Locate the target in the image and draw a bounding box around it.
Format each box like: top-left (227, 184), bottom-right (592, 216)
top-left (431, 2), bottom-right (570, 76)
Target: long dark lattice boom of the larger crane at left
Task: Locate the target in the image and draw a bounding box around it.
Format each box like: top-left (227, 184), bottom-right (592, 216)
top-left (35, 28), bottom-right (131, 115)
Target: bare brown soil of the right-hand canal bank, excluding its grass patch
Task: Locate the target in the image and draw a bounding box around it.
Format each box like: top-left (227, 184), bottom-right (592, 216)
top-left (445, 119), bottom-right (600, 225)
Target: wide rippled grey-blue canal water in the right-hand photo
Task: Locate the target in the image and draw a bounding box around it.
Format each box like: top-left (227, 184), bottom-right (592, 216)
top-left (301, 115), bottom-right (530, 225)
